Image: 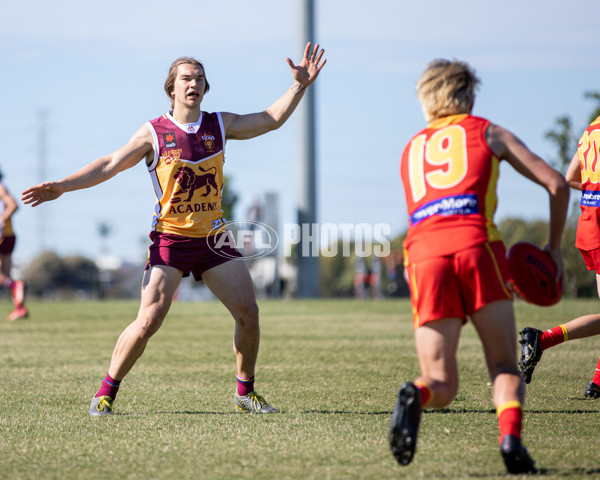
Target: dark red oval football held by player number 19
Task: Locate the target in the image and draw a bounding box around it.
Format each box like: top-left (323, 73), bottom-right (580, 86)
top-left (507, 242), bottom-right (563, 307)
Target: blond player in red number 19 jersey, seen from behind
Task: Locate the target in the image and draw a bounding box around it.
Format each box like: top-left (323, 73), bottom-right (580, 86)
top-left (388, 59), bottom-right (569, 473)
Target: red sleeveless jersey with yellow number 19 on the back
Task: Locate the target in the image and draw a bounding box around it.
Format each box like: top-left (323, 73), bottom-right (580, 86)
top-left (400, 114), bottom-right (501, 262)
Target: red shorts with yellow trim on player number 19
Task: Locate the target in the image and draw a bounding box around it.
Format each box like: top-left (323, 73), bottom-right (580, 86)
top-left (406, 242), bottom-right (512, 330)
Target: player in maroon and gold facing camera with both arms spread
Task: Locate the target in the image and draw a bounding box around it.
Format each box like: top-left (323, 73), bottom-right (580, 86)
top-left (23, 43), bottom-right (326, 416)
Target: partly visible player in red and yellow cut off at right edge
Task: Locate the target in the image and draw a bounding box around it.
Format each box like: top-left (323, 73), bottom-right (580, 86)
top-left (519, 117), bottom-right (600, 398)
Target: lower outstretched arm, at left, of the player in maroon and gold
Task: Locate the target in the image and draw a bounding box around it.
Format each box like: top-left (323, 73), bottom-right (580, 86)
top-left (21, 125), bottom-right (153, 207)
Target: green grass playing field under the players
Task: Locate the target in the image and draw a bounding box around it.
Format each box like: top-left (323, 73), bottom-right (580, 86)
top-left (0, 300), bottom-right (600, 480)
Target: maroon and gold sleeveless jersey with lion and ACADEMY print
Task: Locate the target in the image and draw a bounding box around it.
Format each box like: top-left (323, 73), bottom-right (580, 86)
top-left (146, 112), bottom-right (225, 238)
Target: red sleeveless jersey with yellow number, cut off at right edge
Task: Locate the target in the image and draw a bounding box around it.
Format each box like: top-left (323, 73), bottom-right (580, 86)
top-left (575, 117), bottom-right (600, 250)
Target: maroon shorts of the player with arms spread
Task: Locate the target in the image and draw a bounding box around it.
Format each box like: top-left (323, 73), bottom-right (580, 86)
top-left (146, 231), bottom-right (243, 280)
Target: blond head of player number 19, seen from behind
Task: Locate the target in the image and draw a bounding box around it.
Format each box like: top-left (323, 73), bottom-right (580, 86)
top-left (417, 59), bottom-right (480, 122)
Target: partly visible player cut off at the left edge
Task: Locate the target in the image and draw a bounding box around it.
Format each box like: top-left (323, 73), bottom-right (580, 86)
top-left (0, 172), bottom-right (29, 322)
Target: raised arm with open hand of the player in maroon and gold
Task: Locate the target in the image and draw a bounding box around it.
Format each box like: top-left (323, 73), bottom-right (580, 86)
top-left (222, 42), bottom-right (327, 140)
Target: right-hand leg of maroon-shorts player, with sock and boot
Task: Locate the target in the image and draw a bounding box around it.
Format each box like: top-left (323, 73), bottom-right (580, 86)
top-left (202, 260), bottom-right (276, 413)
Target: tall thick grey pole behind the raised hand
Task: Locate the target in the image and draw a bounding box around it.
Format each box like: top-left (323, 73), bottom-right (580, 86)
top-left (296, 0), bottom-right (320, 298)
